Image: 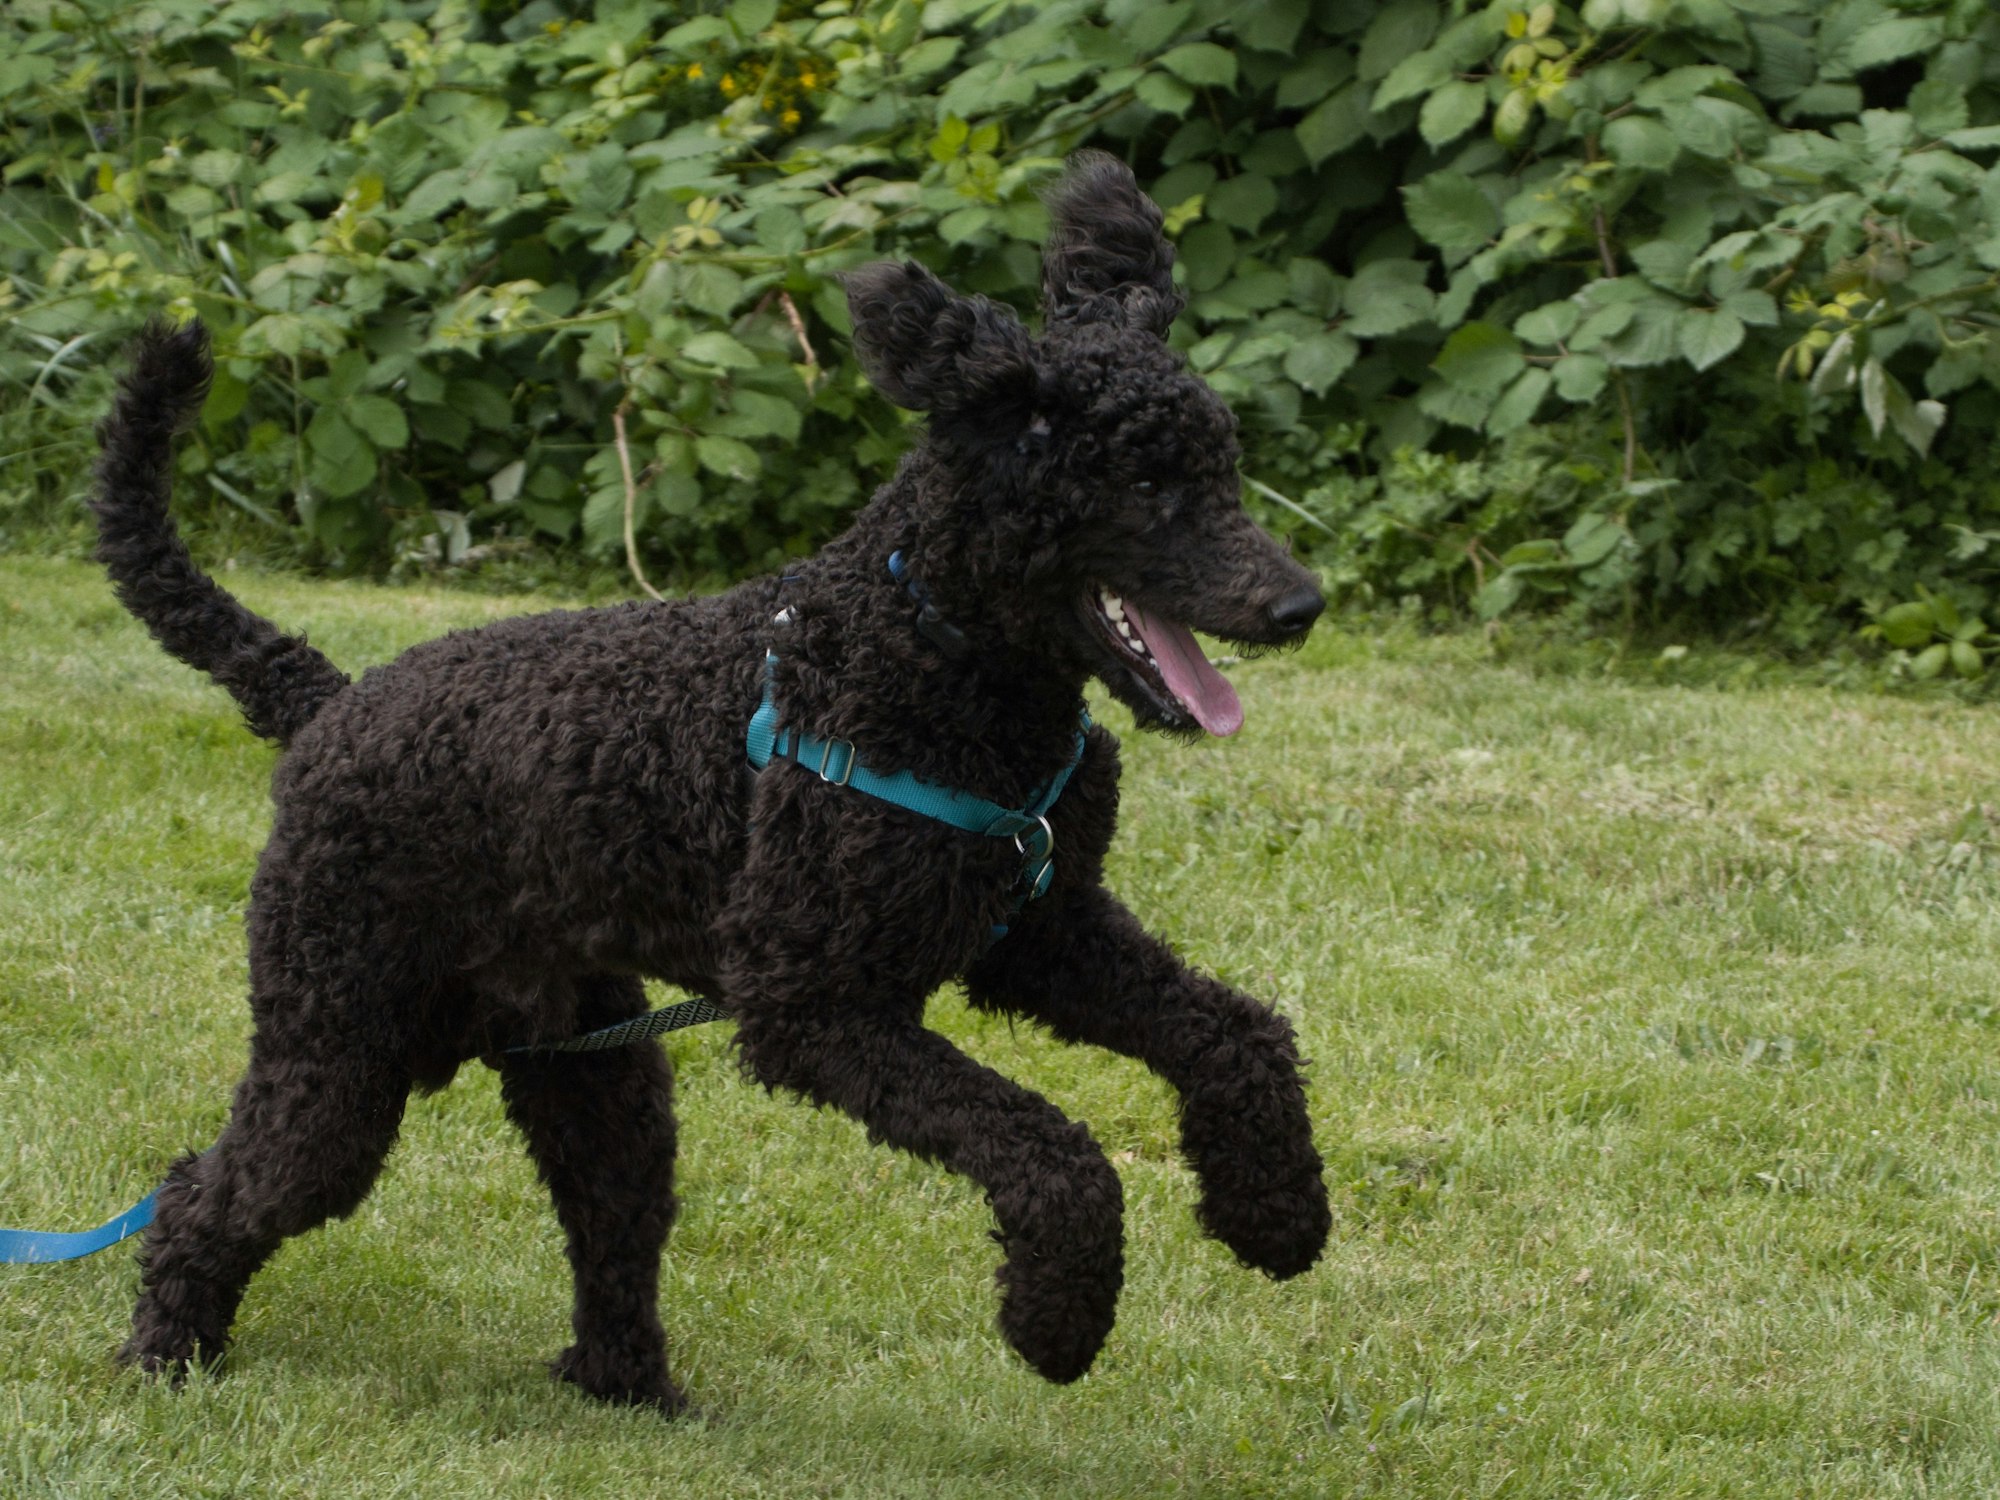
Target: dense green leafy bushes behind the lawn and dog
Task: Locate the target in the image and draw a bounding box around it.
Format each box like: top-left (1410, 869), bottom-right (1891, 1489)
top-left (11, 0), bottom-right (2000, 660)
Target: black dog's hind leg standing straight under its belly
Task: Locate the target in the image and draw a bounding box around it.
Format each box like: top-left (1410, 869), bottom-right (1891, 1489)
top-left (500, 976), bottom-right (686, 1414)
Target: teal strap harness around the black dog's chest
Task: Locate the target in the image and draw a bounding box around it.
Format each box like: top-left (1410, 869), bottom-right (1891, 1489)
top-left (744, 650), bottom-right (1090, 946)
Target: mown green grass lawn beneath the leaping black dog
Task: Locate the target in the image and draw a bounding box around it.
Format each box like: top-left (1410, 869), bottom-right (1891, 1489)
top-left (0, 558), bottom-right (2000, 1500)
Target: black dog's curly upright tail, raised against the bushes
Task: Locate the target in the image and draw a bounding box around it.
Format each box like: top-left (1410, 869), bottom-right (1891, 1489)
top-left (90, 320), bottom-right (348, 744)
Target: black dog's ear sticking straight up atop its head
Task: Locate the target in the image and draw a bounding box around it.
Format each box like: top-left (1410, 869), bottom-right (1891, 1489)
top-left (1042, 152), bottom-right (1186, 338)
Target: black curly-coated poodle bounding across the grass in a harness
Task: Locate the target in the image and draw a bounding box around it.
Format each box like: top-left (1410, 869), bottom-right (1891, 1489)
top-left (94, 154), bottom-right (1330, 1412)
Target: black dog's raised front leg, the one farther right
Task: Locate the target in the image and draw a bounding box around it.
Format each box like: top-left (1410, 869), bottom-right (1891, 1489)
top-left (966, 886), bottom-right (1332, 1278)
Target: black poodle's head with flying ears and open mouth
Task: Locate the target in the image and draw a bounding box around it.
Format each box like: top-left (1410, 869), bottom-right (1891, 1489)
top-left (848, 152), bottom-right (1324, 734)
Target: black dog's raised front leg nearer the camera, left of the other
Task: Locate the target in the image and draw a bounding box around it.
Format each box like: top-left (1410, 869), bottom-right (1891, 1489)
top-left (736, 996), bottom-right (1124, 1382)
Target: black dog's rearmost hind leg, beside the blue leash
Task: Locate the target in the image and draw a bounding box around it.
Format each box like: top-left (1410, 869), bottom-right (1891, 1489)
top-left (120, 1010), bottom-right (410, 1378)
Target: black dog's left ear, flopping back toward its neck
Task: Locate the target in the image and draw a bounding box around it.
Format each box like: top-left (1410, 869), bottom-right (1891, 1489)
top-left (844, 260), bottom-right (1036, 426)
